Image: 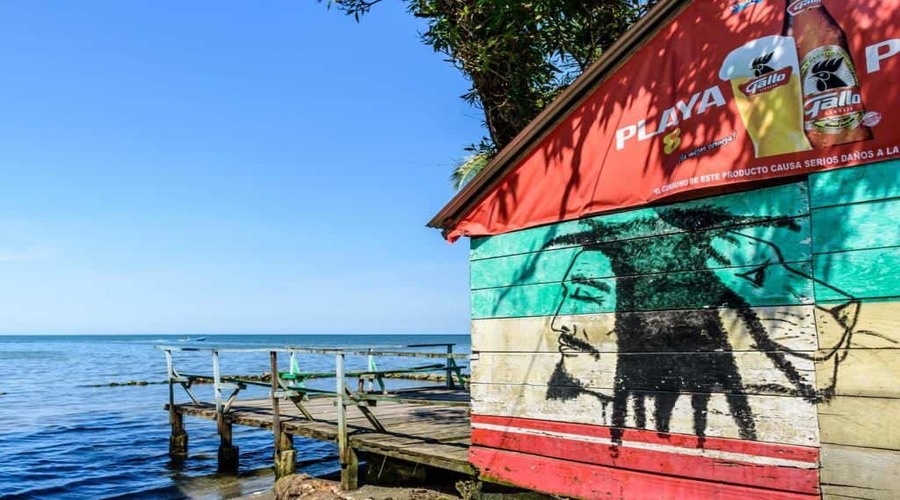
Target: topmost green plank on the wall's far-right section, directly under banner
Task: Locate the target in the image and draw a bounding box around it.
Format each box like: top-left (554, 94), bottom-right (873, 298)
top-left (809, 160), bottom-right (900, 208)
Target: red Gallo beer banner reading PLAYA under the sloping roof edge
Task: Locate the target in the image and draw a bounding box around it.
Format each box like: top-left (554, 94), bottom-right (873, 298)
top-left (447, 0), bottom-right (900, 240)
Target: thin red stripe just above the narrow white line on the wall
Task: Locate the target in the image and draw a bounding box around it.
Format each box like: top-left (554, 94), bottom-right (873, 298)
top-left (472, 415), bottom-right (819, 463)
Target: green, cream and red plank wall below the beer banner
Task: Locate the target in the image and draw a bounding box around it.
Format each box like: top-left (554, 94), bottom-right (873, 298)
top-left (470, 161), bottom-right (900, 499)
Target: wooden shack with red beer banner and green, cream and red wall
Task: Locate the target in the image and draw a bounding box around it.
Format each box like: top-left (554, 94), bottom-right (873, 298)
top-left (430, 0), bottom-right (900, 499)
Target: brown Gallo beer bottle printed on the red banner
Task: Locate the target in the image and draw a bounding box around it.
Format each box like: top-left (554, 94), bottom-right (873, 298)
top-left (782, 0), bottom-right (872, 148)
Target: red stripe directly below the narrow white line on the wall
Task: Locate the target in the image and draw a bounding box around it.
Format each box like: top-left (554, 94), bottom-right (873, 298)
top-left (472, 429), bottom-right (819, 494)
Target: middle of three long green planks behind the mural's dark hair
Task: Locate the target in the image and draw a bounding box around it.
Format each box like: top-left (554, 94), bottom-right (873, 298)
top-left (471, 217), bottom-right (811, 290)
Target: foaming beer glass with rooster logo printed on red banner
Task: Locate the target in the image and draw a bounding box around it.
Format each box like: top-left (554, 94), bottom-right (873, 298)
top-left (719, 36), bottom-right (812, 158)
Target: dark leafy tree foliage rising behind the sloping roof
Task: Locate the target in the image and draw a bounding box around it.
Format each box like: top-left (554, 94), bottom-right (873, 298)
top-left (328, 0), bottom-right (656, 186)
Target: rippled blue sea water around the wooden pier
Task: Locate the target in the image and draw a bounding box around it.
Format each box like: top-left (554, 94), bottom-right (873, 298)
top-left (0, 335), bottom-right (470, 499)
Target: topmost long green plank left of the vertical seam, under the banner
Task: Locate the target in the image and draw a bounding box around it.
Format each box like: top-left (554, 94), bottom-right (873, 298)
top-left (470, 181), bottom-right (809, 260)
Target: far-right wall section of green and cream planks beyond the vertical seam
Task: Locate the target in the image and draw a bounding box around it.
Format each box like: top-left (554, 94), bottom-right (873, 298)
top-left (809, 161), bottom-right (900, 499)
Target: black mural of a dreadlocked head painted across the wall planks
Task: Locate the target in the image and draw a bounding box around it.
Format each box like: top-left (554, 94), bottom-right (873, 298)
top-left (545, 206), bottom-right (892, 442)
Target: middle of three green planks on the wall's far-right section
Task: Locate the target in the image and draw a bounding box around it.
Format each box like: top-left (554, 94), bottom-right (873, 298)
top-left (812, 197), bottom-right (900, 253)
